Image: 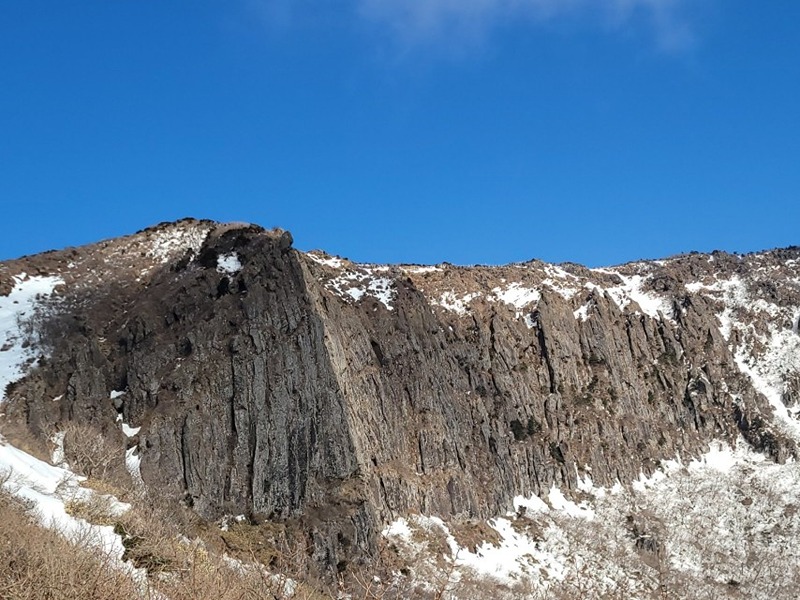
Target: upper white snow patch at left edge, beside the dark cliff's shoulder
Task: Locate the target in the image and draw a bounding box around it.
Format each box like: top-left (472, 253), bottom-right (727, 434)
top-left (0, 274), bottom-right (64, 403)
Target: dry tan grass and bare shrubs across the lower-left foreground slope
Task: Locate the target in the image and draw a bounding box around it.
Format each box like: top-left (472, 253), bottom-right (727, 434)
top-left (0, 424), bottom-right (532, 600)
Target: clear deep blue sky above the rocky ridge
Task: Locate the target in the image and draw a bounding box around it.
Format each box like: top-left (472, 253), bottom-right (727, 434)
top-left (0, 0), bottom-right (800, 266)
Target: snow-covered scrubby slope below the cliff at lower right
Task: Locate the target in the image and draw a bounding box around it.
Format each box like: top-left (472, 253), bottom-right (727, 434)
top-left (383, 440), bottom-right (800, 600)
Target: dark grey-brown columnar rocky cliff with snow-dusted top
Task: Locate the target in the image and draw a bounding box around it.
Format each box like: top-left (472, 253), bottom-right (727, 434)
top-left (0, 220), bottom-right (800, 568)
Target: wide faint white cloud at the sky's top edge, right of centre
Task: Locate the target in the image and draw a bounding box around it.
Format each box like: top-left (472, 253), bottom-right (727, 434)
top-left (355, 0), bottom-right (694, 52)
